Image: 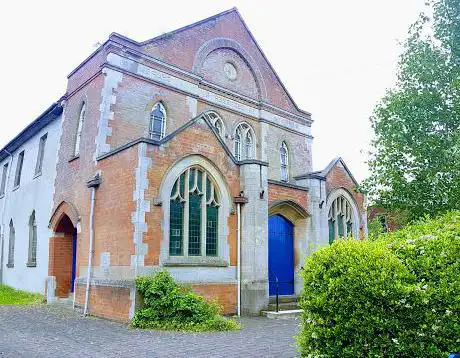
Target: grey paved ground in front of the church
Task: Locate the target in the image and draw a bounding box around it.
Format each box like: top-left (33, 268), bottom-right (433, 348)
top-left (0, 306), bottom-right (299, 358)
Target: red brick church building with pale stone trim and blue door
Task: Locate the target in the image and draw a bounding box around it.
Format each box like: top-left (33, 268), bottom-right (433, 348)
top-left (0, 9), bottom-right (367, 321)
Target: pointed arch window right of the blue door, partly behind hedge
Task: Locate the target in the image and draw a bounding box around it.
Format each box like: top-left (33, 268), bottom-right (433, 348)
top-left (328, 195), bottom-right (354, 244)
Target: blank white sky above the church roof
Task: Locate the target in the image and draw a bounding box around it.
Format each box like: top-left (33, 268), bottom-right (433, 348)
top-left (0, 0), bottom-right (424, 180)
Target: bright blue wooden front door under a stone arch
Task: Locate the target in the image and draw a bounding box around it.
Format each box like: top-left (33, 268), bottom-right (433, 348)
top-left (268, 215), bottom-right (294, 296)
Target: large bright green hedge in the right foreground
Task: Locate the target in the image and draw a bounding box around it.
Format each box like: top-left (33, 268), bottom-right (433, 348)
top-left (298, 212), bottom-right (460, 357)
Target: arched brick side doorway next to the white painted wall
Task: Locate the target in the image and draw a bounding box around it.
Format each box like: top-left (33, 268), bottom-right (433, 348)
top-left (48, 214), bottom-right (77, 297)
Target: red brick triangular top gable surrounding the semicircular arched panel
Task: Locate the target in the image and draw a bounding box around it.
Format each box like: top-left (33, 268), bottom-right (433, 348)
top-left (139, 8), bottom-right (310, 115)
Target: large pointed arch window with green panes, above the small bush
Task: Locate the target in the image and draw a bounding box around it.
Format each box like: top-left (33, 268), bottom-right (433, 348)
top-left (169, 167), bottom-right (220, 256)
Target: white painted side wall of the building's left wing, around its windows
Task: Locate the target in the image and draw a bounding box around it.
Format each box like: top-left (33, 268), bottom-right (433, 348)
top-left (0, 118), bottom-right (61, 293)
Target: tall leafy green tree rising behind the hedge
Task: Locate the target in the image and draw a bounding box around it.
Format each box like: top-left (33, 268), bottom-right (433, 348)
top-left (363, 0), bottom-right (460, 219)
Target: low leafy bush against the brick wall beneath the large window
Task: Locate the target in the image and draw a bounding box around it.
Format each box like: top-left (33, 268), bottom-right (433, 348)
top-left (131, 271), bottom-right (239, 332)
